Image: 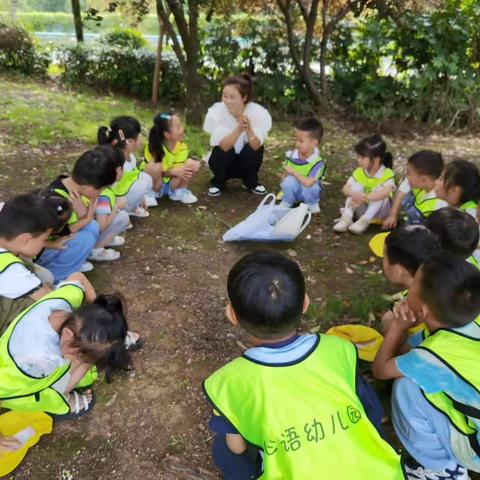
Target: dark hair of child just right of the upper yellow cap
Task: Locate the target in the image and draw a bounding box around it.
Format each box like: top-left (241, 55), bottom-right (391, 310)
top-left (385, 225), bottom-right (440, 276)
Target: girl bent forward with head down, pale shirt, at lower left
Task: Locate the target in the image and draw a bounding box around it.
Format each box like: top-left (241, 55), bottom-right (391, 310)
top-left (0, 280), bottom-right (130, 420)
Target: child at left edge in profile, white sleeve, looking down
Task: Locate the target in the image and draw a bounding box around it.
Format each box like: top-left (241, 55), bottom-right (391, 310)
top-left (0, 193), bottom-right (86, 335)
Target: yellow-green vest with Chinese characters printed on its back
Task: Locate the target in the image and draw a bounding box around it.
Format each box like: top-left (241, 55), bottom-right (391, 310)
top-left (203, 335), bottom-right (404, 480)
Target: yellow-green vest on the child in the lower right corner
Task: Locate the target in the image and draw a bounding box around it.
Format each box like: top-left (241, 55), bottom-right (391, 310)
top-left (417, 326), bottom-right (480, 456)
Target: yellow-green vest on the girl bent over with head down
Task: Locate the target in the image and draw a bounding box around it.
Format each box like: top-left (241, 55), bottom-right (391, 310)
top-left (0, 284), bottom-right (85, 415)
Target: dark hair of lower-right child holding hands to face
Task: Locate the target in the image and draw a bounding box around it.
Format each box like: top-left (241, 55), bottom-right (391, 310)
top-left (419, 251), bottom-right (480, 328)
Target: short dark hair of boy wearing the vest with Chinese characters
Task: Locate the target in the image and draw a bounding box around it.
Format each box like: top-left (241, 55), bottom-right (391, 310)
top-left (227, 251), bottom-right (305, 340)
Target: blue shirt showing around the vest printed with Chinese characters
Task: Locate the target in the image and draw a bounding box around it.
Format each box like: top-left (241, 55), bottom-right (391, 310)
top-left (209, 335), bottom-right (384, 437)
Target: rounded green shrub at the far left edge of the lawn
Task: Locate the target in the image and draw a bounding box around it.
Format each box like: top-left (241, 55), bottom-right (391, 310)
top-left (0, 20), bottom-right (50, 76)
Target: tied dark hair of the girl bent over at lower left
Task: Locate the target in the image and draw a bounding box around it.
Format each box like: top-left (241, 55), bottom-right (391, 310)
top-left (60, 295), bottom-right (131, 382)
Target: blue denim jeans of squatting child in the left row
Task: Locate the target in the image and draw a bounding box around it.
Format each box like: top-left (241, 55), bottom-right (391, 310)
top-left (36, 220), bottom-right (100, 283)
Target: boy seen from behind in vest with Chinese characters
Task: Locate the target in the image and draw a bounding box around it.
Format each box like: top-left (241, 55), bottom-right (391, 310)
top-left (203, 252), bottom-right (403, 480)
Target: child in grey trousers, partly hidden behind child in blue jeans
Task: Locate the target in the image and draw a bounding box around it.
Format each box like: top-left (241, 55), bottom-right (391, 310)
top-left (92, 145), bottom-right (130, 258)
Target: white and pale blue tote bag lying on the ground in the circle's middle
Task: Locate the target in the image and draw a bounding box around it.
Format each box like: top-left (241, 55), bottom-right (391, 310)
top-left (223, 193), bottom-right (312, 242)
